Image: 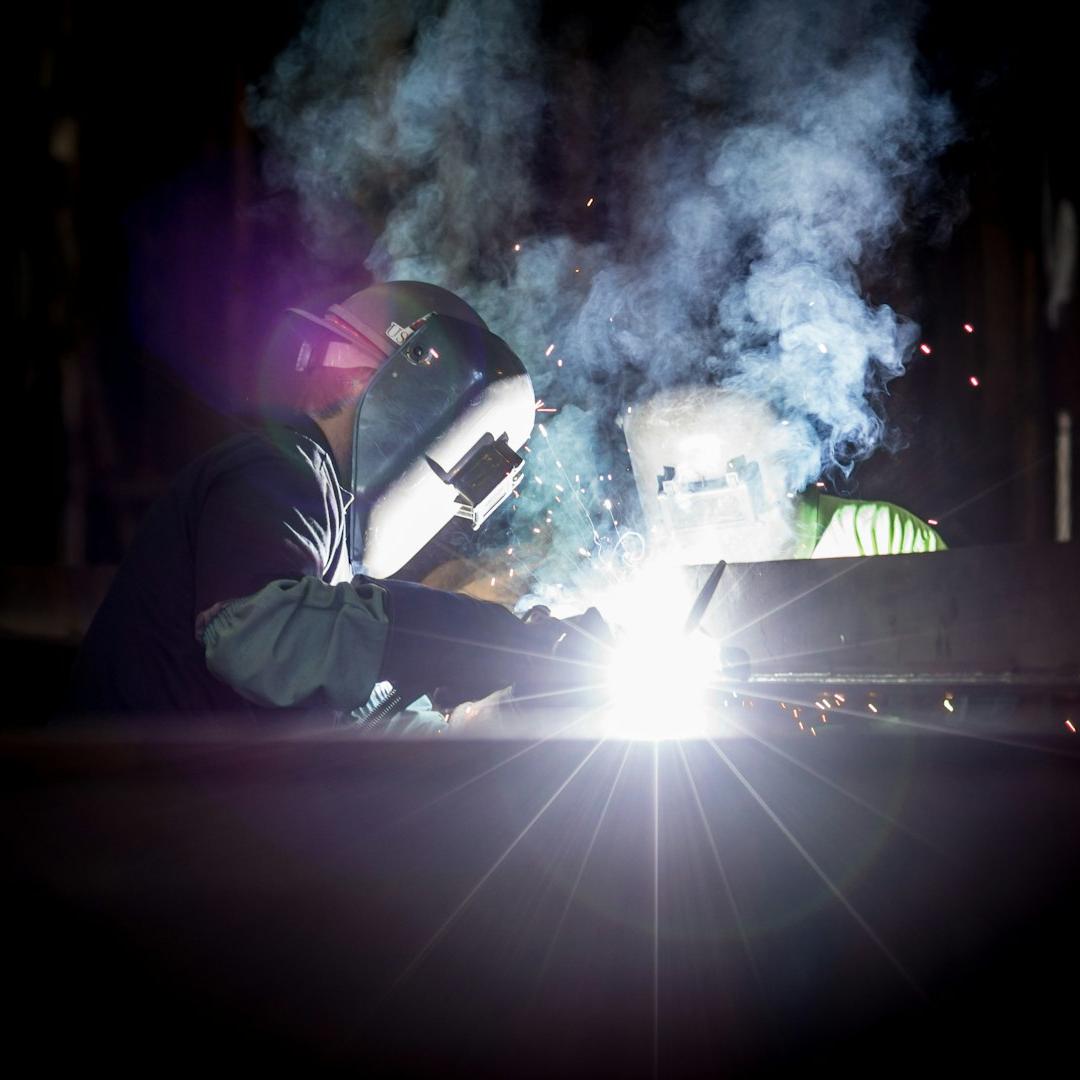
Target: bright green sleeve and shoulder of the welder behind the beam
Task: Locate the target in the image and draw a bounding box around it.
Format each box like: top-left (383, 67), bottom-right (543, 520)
top-left (794, 495), bottom-right (946, 558)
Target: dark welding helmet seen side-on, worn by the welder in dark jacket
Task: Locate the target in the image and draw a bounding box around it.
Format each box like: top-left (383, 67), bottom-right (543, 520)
top-left (282, 281), bottom-right (535, 578)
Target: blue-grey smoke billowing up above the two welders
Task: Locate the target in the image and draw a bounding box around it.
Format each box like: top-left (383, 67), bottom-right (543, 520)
top-left (251, 0), bottom-right (954, 580)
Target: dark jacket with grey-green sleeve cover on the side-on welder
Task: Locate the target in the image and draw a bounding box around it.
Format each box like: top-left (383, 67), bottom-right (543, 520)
top-left (72, 418), bottom-right (534, 716)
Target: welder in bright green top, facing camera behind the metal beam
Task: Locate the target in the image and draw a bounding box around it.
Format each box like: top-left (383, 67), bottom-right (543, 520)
top-left (623, 387), bottom-right (945, 565)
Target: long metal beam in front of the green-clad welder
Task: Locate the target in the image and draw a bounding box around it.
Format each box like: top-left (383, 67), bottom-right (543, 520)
top-left (688, 543), bottom-right (1080, 688)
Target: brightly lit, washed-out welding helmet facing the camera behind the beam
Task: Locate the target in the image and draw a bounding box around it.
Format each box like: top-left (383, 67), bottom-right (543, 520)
top-left (622, 387), bottom-right (805, 566)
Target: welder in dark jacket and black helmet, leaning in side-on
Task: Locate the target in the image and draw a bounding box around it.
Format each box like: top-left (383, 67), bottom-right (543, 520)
top-left (72, 282), bottom-right (599, 730)
